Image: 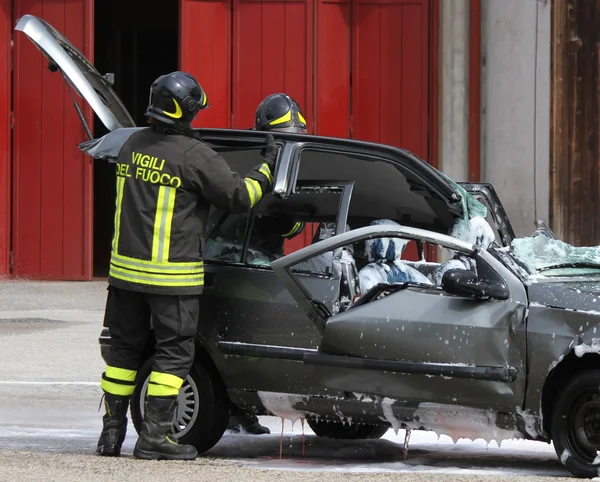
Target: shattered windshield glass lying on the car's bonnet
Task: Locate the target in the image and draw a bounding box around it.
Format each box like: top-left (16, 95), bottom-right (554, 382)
top-left (510, 232), bottom-right (600, 276)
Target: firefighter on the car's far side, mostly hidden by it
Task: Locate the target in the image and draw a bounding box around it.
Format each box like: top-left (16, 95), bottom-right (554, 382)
top-left (227, 93), bottom-right (307, 435)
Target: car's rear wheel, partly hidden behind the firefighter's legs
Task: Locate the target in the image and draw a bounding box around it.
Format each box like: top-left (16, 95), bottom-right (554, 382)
top-left (131, 358), bottom-right (229, 453)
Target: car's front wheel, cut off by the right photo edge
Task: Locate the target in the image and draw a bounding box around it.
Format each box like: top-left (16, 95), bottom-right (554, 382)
top-left (551, 370), bottom-right (600, 478)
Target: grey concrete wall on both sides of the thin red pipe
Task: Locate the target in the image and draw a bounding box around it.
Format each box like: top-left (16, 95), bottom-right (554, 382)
top-left (439, 0), bottom-right (551, 236)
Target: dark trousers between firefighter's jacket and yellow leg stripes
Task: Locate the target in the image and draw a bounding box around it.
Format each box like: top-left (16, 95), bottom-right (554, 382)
top-left (104, 286), bottom-right (200, 383)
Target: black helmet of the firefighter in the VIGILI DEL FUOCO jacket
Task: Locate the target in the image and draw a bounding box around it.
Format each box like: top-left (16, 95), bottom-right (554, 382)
top-left (146, 71), bottom-right (208, 125)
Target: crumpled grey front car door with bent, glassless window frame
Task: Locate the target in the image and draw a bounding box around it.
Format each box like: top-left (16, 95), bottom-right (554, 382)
top-left (273, 226), bottom-right (527, 412)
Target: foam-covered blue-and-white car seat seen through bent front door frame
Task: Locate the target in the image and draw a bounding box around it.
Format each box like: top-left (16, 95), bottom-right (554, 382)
top-left (358, 219), bottom-right (432, 294)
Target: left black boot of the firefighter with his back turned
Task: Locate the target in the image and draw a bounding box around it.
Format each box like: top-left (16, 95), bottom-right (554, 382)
top-left (96, 392), bottom-right (129, 457)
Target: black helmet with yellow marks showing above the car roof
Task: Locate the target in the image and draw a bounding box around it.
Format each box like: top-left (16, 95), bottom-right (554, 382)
top-left (254, 94), bottom-right (306, 133)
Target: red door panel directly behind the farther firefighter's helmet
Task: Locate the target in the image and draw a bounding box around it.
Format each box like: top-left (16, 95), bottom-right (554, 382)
top-left (232, 0), bottom-right (312, 131)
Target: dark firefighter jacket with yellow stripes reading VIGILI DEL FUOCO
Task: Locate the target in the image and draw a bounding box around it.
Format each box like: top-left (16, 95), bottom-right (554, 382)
top-left (108, 127), bottom-right (273, 295)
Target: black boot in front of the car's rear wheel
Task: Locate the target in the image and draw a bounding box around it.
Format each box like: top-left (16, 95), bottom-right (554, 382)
top-left (133, 397), bottom-right (198, 460)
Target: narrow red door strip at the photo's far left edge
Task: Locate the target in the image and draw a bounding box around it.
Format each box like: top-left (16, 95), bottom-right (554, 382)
top-left (0, 0), bottom-right (12, 278)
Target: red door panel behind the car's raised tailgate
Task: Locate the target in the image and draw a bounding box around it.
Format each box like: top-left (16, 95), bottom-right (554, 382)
top-left (11, 0), bottom-right (93, 280)
